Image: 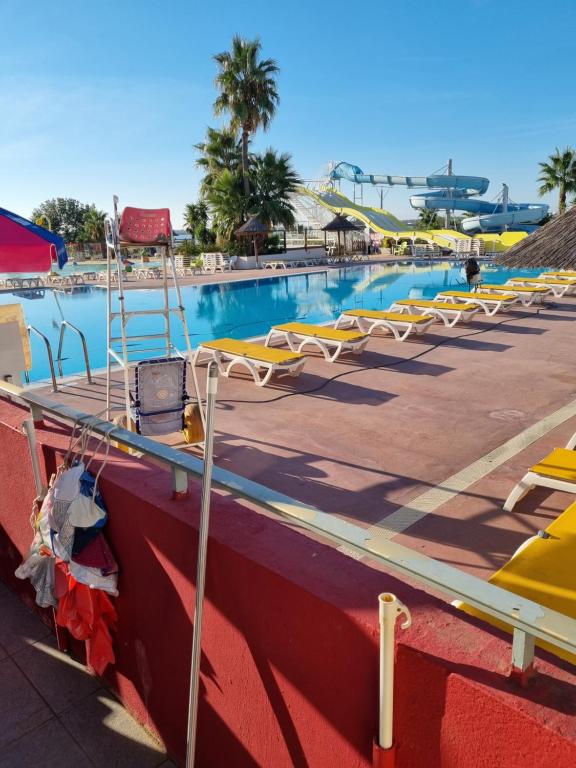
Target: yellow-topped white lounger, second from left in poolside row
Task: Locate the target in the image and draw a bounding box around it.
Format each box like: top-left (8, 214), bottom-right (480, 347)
top-left (266, 323), bottom-right (370, 363)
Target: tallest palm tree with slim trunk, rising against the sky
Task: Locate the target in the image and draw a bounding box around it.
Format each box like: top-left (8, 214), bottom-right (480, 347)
top-left (214, 35), bottom-right (280, 197)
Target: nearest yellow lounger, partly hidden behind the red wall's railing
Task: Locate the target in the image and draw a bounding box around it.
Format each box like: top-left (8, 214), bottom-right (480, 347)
top-left (455, 504), bottom-right (576, 664)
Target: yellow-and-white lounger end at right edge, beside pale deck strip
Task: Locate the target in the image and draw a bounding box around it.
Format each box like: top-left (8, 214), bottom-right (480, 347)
top-left (504, 432), bottom-right (576, 512)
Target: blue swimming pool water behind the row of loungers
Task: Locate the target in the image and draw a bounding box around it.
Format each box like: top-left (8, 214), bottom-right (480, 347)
top-left (0, 262), bottom-right (541, 381)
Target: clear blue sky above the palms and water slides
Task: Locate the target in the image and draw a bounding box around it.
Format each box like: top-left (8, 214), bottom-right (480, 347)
top-left (0, 0), bottom-right (576, 226)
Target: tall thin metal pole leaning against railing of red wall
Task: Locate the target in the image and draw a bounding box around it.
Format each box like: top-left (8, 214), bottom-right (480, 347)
top-left (186, 362), bottom-right (218, 768)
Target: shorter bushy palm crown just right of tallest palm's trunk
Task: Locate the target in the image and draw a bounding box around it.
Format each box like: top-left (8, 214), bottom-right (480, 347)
top-left (250, 149), bottom-right (301, 227)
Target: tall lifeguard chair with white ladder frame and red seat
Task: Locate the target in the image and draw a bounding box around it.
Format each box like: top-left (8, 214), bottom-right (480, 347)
top-left (105, 195), bottom-right (205, 440)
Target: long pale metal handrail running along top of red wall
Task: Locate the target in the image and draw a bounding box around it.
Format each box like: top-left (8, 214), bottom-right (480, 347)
top-left (0, 381), bottom-right (576, 672)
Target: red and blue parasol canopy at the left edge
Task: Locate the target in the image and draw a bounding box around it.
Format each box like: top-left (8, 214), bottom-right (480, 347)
top-left (0, 208), bottom-right (68, 272)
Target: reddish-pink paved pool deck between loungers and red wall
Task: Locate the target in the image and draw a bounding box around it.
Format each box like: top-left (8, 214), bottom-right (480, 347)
top-left (30, 290), bottom-right (576, 578)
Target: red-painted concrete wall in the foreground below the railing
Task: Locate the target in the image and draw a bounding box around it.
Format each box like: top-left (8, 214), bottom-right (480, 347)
top-left (0, 401), bottom-right (576, 768)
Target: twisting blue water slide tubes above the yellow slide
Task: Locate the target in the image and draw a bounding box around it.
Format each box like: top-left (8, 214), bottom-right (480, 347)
top-left (330, 162), bottom-right (548, 234)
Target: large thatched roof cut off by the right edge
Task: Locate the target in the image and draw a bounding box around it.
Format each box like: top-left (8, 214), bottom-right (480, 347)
top-left (498, 205), bottom-right (576, 269)
